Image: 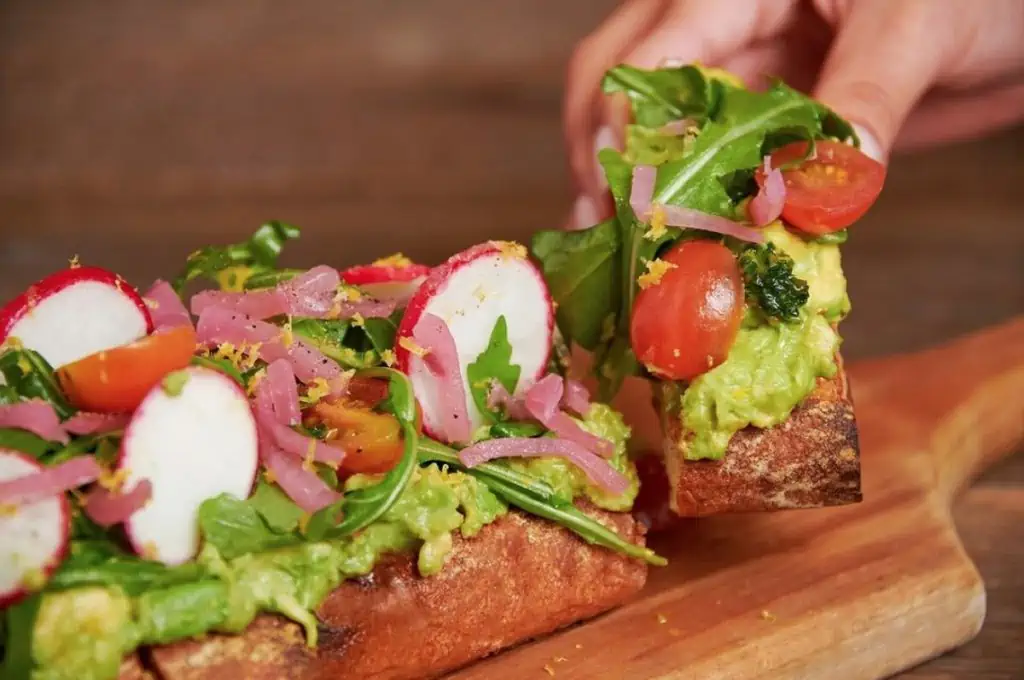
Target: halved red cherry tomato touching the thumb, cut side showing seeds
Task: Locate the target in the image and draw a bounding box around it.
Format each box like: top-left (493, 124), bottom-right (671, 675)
top-left (756, 141), bottom-right (886, 236)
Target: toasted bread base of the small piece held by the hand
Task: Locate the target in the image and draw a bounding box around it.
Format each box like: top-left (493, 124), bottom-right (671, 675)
top-left (654, 368), bottom-right (861, 517)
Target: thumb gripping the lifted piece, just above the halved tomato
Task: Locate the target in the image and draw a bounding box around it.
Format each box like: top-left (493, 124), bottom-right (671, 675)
top-left (814, 0), bottom-right (954, 162)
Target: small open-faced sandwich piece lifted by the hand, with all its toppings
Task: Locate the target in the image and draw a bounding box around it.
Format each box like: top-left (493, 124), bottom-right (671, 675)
top-left (532, 66), bottom-right (885, 516)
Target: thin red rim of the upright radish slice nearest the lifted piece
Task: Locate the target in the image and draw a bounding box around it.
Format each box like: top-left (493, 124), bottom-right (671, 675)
top-left (394, 241), bottom-right (555, 437)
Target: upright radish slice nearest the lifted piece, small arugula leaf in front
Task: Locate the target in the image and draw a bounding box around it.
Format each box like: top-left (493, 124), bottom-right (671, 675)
top-left (395, 242), bottom-right (555, 437)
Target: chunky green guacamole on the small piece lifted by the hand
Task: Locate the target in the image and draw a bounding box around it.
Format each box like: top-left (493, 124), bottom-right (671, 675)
top-left (662, 222), bottom-right (850, 460)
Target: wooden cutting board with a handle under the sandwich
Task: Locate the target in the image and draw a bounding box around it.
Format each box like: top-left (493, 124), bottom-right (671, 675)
top-left (452, 317), bottom-right (1024, 680)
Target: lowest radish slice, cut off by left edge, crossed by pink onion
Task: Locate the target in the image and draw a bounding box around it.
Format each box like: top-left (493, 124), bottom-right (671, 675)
top-left (0, 449), bottom-right (71, 609)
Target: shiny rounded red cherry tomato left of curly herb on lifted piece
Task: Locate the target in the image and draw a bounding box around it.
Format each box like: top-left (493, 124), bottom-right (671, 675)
top-left (630, 240), bottom-right (743, 380)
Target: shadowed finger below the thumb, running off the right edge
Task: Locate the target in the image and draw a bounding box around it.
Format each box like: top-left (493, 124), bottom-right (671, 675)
top-left (896, 83), bottom-right (1024, 151)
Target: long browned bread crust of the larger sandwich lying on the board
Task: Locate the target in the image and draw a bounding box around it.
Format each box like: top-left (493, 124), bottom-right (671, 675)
top-left (142, 509), bottom-right (647, 680)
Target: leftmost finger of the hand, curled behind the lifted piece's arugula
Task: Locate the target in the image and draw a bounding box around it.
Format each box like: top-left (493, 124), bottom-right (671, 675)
top-left (562, 0), bottom-right (666, 202)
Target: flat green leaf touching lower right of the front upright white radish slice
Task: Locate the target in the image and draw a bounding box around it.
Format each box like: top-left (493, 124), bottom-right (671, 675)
top-left (199, 494), bottom-right (302, 559)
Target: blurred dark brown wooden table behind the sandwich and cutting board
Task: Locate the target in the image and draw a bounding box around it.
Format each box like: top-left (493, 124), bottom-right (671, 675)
top-left (0, 0), bottom-right (1024, 680)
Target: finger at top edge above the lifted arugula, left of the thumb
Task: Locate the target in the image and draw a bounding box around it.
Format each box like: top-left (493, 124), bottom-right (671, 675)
top-left (626, 0), bottom-right (797, 69)
